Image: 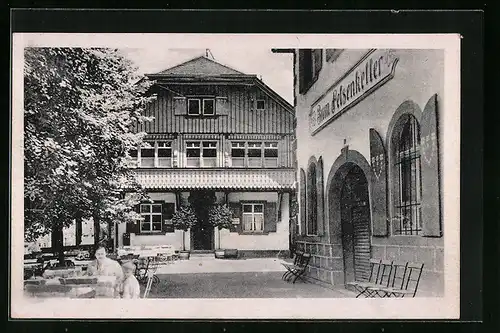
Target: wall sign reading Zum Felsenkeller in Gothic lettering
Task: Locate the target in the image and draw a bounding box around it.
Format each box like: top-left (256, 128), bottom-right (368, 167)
top-left (309, 49), bottom-right (398, 135)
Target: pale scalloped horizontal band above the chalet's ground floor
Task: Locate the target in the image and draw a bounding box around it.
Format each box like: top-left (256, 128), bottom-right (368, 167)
top-left (134, 168), bottom-right (295, 190)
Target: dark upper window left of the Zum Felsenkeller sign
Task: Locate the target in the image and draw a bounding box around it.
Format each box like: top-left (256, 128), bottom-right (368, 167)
top-left (299, 49), bottom-right (323, 94)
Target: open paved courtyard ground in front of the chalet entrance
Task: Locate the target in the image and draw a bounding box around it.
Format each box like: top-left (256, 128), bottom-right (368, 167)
top-left (141, 258), bottom-right (354, 298)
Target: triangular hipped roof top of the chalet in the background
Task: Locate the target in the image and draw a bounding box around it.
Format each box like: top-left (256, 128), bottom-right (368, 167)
top-left (154, 56), bottom-right (243, 75)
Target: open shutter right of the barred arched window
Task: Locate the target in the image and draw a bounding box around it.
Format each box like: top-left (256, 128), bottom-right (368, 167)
top-left (420, 95), bottom-right (442, 237)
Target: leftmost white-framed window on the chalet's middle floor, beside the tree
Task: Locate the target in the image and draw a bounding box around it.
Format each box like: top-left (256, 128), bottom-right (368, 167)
top-left (136, 141), bottom-right (172, 168)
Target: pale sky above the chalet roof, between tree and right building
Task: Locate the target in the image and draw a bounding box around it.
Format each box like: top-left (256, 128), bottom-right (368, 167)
top-left (123, 46), bottom-right (293, 104)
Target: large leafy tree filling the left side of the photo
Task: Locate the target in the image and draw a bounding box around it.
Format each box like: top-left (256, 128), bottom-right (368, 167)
top-left (24, 48), bottom-right (155, 260)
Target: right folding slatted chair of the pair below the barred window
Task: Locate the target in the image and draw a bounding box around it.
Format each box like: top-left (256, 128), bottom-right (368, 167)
top-left (368, 262), bottom-right (424, 297)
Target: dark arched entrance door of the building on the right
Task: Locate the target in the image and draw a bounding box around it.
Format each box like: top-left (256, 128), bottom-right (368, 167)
top-left (340, 166), bottom-right (371, 283)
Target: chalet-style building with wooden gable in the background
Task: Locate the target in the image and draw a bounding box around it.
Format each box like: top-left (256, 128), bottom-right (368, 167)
top-left (117, 56), bottom-right (296, 255)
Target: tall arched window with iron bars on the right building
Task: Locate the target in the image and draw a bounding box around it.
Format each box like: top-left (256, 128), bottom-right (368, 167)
top-left (393, 114), bottom-right (422, 235)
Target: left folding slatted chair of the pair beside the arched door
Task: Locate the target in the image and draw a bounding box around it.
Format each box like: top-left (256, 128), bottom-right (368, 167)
top-left (347, 259), bottom-right (393, 298)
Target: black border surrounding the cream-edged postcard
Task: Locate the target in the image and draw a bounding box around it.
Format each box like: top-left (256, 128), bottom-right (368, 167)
top-left (4, 3), bottom-right (488, 332)
